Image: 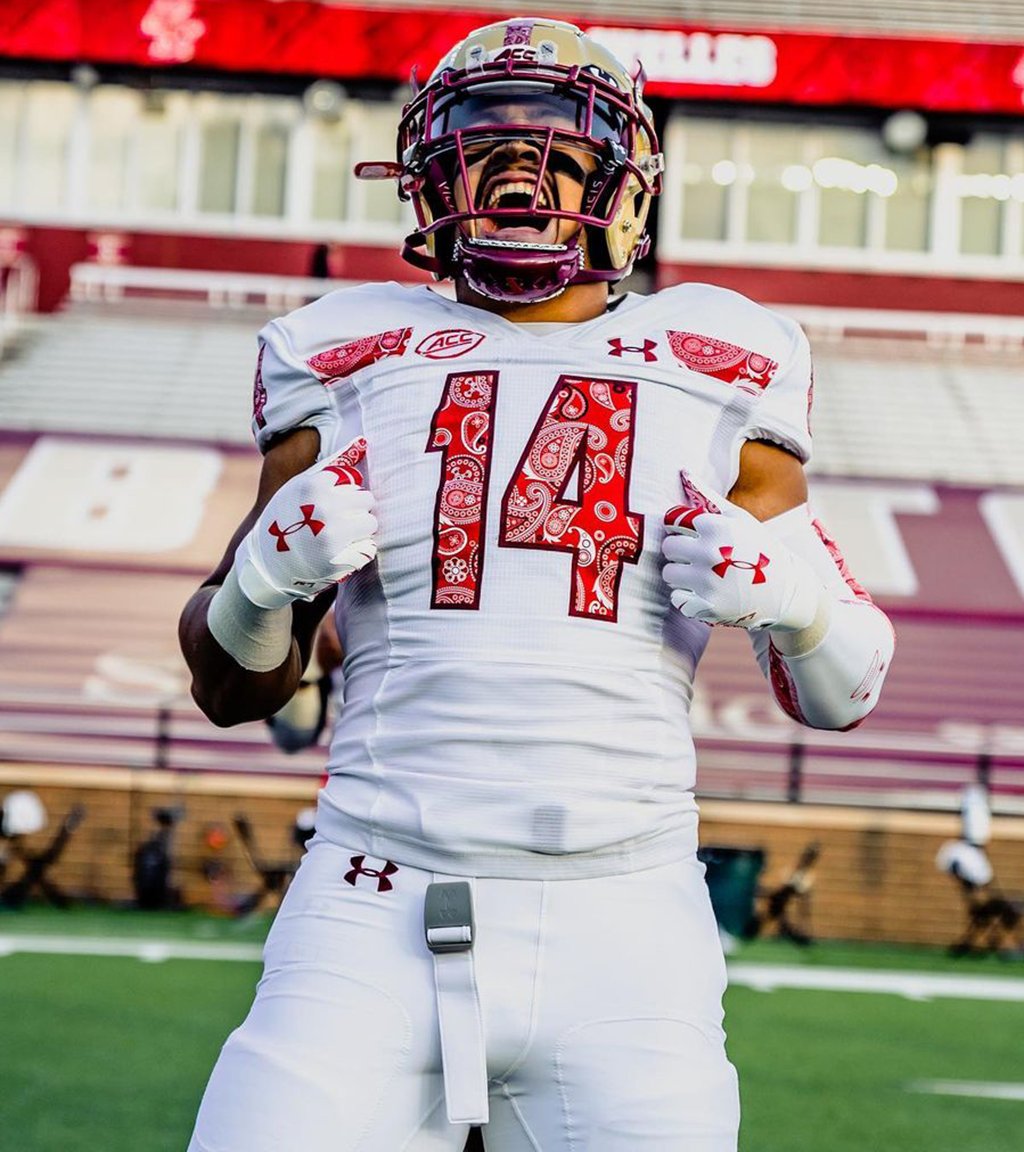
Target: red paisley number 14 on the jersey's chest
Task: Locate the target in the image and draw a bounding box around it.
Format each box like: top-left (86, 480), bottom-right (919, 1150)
top-left (427, 372), bottom-right (644, 621)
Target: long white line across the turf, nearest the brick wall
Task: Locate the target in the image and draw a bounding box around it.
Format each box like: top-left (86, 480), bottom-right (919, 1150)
top-left (0, 933), bottom-right (1024, 1002)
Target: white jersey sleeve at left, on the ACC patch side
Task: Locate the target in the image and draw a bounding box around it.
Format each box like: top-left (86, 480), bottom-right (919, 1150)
top-left (252, 320), bottom-right (336, 455)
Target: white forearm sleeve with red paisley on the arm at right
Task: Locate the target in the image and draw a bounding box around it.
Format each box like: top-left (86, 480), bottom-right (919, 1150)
top-left (750, 505), bottom-right (895, 729)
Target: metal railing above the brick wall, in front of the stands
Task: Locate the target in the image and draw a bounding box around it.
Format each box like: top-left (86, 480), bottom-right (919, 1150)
top-left (0, 694), bottom-right (1024, 816)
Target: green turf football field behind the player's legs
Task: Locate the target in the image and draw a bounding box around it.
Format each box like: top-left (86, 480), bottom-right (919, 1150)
top-left (0, 909), bottom-right (1024, 1152)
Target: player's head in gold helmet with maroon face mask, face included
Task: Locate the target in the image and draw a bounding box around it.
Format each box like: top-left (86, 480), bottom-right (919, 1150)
top-left (377, 21), bottom-right (661, 303)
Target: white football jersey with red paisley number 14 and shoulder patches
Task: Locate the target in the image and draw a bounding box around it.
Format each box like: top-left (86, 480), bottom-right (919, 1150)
top-left (253, 283), bottom-right (811, 878)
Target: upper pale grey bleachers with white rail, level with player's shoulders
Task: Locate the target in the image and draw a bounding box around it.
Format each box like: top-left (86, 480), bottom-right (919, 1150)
top-left (0, 265), bottom-right (1024, 485)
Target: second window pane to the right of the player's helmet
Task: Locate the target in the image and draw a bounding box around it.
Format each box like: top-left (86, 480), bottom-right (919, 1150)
top-left (737, 124), bottom-right (806, 244)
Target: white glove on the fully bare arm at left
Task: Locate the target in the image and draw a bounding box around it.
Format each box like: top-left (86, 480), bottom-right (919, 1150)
top-left (235, 438), bottom-right (377, 608)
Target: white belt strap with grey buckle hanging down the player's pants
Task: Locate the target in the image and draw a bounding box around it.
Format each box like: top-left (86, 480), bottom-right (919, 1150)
top-left (423, 880), bottom-right (488, 1124)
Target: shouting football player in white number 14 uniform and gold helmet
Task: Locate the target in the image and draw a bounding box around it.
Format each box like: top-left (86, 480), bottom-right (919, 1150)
top-left (181, 18), bottom-right (893, 1152)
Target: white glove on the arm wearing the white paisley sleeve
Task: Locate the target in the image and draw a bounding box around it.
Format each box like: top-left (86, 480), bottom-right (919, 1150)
top-left (661, 472), bottom-right (824, 631)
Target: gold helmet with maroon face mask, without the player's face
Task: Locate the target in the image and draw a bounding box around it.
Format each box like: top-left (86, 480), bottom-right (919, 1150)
top-left (393, 18), bottom-right (663, 300)
